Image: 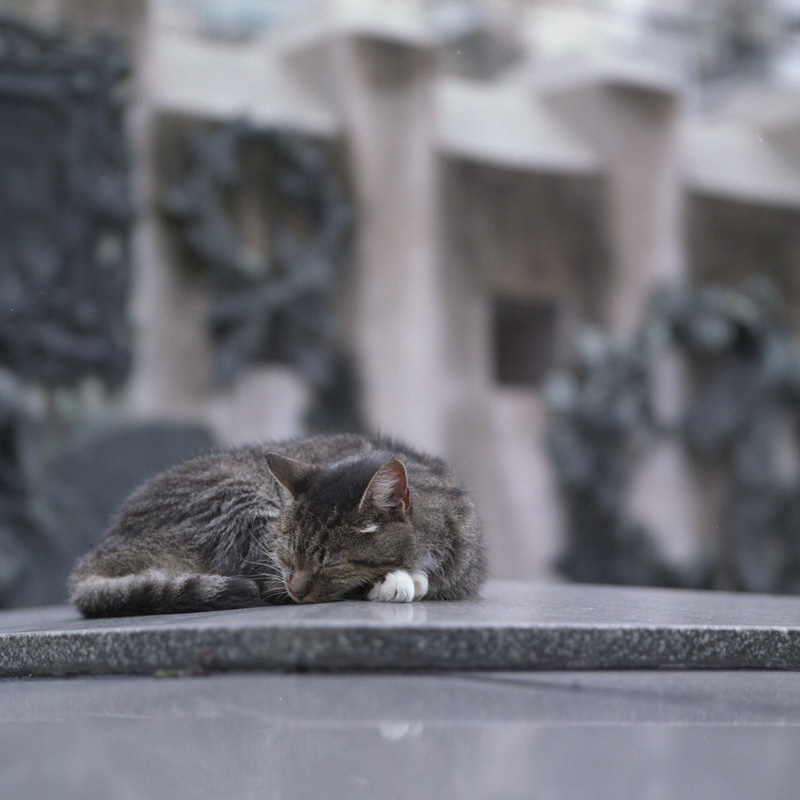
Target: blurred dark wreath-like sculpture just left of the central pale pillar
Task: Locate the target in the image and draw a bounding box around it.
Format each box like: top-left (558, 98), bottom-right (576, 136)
top-left (163, 121), bottom-right (359, 430)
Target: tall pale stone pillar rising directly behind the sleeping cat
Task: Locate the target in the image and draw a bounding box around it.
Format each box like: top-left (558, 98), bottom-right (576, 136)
top-left (336, 36), bottom-right (447, 451)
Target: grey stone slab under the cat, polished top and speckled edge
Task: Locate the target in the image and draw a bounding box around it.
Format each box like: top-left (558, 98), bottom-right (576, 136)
top-left (0, 581), bottom-right (800, 676)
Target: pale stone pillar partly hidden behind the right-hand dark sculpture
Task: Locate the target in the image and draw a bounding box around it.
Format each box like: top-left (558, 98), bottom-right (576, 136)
top-left (598, 83), bottom-right (703, 562)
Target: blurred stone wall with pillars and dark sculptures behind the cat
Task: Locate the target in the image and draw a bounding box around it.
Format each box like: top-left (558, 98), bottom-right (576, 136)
top-left (0, 0), bottom-right (800, 606)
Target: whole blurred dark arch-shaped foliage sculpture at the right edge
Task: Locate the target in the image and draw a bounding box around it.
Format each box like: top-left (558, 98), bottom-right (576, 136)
top-left (548, 278), bottom-right (800, 593)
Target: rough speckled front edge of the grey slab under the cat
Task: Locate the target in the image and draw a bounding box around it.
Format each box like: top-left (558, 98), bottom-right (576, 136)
top-left (0, 626), bottom-right (800, 677)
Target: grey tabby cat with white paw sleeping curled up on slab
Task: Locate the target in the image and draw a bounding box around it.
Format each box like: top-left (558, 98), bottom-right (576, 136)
top-left (69, 434), bottom-right (487, 617)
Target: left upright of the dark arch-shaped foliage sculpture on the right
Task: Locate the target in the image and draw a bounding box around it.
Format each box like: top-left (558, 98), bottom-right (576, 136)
top-left (548, 330), bottom-right (675, 585)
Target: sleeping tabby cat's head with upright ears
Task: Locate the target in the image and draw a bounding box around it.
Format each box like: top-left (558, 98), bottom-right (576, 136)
top-left (267, 453), bottom-right (414, 603)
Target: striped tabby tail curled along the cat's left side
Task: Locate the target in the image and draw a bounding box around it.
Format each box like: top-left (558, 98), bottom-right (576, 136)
top-left (70, 569), bottom-right (263, 617)
